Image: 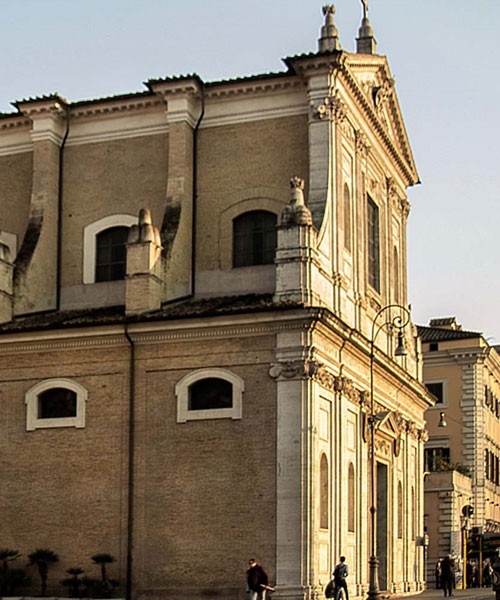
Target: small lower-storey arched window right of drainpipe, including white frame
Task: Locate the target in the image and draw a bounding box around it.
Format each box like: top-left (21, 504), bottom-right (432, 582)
top-left (175, 368), bottom-right (245, 423)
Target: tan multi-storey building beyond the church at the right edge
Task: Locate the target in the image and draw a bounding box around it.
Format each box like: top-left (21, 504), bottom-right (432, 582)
top-left (418, 317), bottom-right (500, 584)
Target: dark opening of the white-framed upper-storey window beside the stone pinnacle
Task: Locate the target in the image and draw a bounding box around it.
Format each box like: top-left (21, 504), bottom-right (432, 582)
top-left (95, 227), bottom-right (129, 282)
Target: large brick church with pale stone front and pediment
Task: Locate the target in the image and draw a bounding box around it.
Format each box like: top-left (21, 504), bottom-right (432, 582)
top-left (0, 7), bottom-right (431, 599)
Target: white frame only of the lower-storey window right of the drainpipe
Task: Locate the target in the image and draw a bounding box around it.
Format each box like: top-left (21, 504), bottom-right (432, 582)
top-left (175, 368), bottom-right (245, 423)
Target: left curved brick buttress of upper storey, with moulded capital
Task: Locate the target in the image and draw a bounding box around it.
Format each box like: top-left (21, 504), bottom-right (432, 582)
top-left (14, 96), bottom-right (67, 314)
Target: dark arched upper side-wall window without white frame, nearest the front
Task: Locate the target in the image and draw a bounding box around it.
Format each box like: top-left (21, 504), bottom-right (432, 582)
top-left (233, 210), bottom-right (276, 267)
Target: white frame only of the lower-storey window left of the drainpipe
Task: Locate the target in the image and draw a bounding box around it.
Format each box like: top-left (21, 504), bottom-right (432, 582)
top-left (25, 378), bottom-right (88, 431)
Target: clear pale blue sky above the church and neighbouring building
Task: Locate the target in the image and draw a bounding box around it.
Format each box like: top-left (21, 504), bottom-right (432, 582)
top-left (0, 0), bottom-right (500, 344)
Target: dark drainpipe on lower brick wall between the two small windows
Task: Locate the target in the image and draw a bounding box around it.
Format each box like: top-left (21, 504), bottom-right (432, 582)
top-left (124, 325), bottom-right (135, 600)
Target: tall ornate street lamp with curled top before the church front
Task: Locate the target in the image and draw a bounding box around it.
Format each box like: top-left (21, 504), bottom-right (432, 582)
top-left (368, 304), bottom-right (410, 600)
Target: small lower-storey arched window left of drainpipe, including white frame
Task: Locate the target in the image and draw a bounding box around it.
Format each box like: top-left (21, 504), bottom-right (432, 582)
top-left (25, 379), bottom-right (87, 431)
